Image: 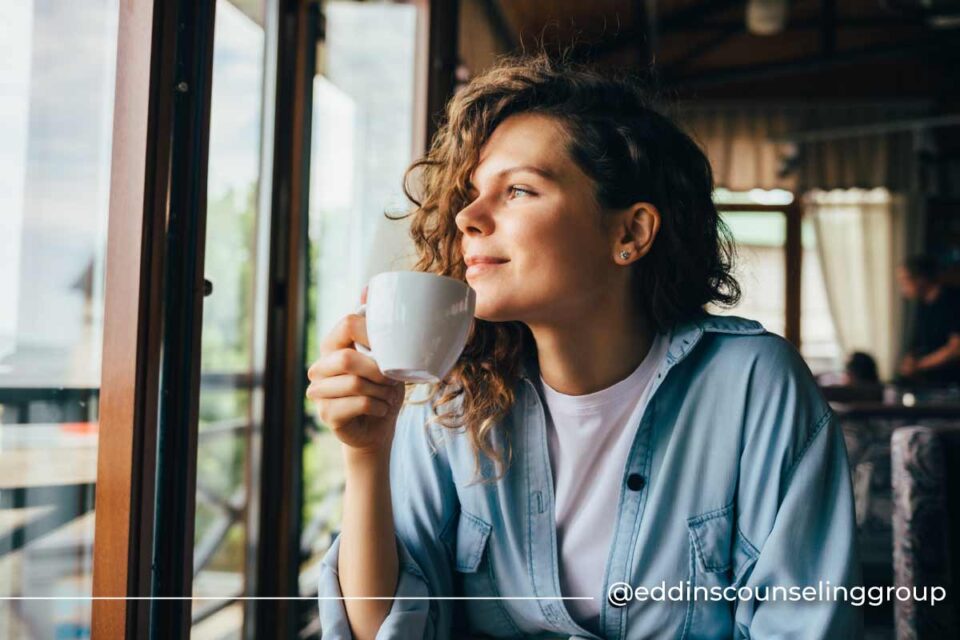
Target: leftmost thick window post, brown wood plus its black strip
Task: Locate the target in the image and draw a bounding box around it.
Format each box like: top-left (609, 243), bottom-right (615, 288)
top-left (92, 0), bottom-right (215, 640)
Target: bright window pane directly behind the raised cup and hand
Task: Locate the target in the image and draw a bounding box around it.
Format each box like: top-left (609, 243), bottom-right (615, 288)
top-left (300, 2), bottom-right (417, 632)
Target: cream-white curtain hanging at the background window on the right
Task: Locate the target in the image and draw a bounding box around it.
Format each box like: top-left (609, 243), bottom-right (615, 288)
top-left (803, 188), bottom-right (905, 379)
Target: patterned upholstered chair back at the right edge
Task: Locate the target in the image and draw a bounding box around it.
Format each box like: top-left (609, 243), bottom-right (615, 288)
top-left (891, 426), bottom-right (960, 640)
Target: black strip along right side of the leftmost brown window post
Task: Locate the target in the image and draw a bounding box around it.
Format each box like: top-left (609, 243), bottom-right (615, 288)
top-left (150, 0), bottom-right (216, 639)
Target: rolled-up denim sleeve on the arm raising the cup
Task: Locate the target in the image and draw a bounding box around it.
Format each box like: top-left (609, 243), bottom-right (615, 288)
top-left (319, 404), bottom-right (458, 640)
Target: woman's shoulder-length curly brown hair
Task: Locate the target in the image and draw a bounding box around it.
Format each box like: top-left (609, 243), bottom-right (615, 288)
top-left (394, 53), bottom-right (740, 480)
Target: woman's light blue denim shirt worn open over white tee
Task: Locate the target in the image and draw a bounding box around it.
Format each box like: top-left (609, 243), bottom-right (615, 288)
top-left (319, 315), bottom-right (862, 640)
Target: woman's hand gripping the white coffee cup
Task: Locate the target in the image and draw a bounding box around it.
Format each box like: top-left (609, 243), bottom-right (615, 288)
top-left (307, 291), bottom-right (404, 457)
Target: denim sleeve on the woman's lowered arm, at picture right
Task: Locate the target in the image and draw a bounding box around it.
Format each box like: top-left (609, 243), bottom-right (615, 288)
top-left (734, 336), bottom-right (863, 638)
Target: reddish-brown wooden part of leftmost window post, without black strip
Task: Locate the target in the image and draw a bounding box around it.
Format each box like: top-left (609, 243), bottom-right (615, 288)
top-left (92, 0), bottom-right (175, 640)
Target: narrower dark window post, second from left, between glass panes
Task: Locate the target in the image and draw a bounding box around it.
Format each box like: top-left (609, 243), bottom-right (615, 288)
top-left (254, 0), bottom-right (320, 639)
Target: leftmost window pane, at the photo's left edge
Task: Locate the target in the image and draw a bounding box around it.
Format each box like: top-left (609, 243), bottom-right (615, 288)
top-left (0, 0), bottom-right (118, 639)
